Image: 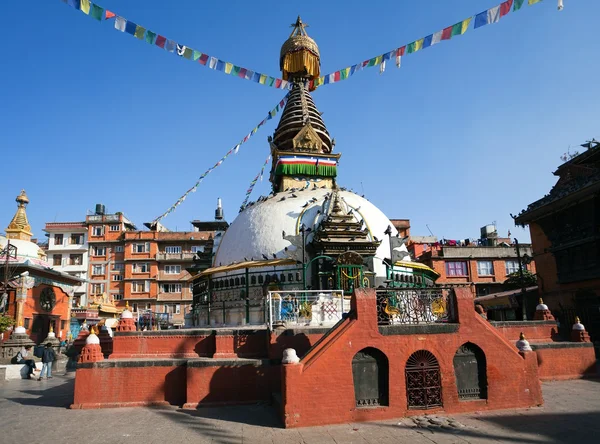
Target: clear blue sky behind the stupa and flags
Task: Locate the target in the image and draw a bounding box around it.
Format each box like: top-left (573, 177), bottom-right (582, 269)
top-left (0, 0), bottom-right (600, 240)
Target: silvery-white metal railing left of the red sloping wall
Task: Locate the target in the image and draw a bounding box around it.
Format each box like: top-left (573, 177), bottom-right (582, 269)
top-left (266, 290), bottom-right (350, 330)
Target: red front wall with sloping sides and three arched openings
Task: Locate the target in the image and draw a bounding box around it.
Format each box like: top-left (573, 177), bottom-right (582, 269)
top-left (282, 288), bottom-right (543, 427)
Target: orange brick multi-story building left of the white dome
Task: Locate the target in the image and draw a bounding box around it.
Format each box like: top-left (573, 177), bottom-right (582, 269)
top-left (86, 205), bottom-right (227, 328)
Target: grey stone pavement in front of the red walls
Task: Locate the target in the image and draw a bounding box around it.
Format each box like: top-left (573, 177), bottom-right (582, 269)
top-left (0, 375), bottom-right (600, 444)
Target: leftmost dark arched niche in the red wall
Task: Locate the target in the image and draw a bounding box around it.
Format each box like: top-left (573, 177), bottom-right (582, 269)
top-left (352, 347), bottom-right (389, 407)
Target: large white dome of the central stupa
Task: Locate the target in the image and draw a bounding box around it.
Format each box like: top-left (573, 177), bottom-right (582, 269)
top-left (214, 187), bottom-right (410, 276)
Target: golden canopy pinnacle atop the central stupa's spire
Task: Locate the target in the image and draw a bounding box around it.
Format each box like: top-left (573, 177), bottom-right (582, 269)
top-left (279, 16), bottom-right (321, 81)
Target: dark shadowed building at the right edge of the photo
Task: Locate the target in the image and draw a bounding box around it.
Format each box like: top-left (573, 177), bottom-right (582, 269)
top-left (515, 140), bottom-right (600, 340)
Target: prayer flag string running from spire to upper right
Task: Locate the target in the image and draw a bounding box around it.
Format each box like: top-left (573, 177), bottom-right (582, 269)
top-left (308, 0), bottom-right (548, 89)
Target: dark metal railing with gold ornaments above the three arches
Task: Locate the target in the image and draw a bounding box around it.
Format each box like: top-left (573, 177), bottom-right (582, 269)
top-left (377, 288), bottom-right (456, 325)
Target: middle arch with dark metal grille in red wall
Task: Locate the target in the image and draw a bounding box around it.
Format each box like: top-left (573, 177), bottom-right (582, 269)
top-left (405, 350), bottom-right (442, 410)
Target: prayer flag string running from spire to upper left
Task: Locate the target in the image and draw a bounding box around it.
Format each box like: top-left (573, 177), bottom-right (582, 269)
top-left (57, 0), bottom-right (292, 90)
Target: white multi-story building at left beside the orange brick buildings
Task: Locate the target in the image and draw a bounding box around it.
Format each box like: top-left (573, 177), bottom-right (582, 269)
top-left (44, 222), bottom-right (88, 307)
